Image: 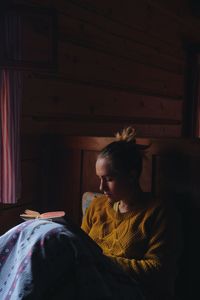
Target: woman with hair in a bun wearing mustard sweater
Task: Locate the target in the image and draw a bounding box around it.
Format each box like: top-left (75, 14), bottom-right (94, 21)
top-left (81, 127), bottom-right (183, 300)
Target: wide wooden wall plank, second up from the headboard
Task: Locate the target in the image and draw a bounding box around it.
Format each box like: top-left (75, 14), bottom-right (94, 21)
top-left (22, 75), bottom-right (182, 120)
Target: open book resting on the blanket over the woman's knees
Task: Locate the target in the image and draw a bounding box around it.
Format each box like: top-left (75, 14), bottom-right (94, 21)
top-left (20, 209), bottom-right (65, 220)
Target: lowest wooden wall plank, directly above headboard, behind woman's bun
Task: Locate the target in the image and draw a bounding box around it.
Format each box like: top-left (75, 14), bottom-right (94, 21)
top-left (22, 117), bottom-right (182, 137)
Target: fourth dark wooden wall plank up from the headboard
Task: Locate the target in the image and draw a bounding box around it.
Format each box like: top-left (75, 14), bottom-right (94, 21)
top-left (59, 11), bottom-right (183, 73)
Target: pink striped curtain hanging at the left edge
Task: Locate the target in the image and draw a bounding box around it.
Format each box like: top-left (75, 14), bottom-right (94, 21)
top-left (0, 70), bottom-right (21, 203)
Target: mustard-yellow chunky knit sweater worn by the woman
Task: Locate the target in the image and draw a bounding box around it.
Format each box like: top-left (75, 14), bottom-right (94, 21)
top-left (81, 196), bottom-right (180, 300)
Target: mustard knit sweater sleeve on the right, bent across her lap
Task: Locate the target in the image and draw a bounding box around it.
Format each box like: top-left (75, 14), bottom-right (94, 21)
top-left (104, 204), bottom-right (181, 282)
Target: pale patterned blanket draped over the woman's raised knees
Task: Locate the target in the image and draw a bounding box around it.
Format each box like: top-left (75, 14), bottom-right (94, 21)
top-left (0, 219), bottom-right (144, 300)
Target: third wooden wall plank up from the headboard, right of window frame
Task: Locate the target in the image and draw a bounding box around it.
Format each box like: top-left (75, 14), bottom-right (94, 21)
top-left (58, 43), bottom-right (184, 97)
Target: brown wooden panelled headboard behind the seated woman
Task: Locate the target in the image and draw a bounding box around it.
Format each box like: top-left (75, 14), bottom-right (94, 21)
top-left (41, 135), bottom-right (200, 223)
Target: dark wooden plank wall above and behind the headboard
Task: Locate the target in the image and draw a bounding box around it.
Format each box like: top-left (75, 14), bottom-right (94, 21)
top-left (0, 0), bottom-right (200, 232)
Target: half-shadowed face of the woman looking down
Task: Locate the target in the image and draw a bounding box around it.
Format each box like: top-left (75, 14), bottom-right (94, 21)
top-left (96, 158), bottom-right (133, 202)
